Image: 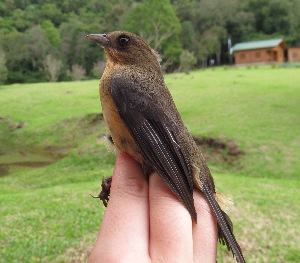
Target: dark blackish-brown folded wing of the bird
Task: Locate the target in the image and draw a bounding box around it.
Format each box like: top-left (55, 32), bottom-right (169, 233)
top-left (111, 77), bottom-right (197, 220)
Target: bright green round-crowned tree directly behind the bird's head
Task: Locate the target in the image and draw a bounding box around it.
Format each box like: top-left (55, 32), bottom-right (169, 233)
top-left (123, 0), bottom-right (181, 69)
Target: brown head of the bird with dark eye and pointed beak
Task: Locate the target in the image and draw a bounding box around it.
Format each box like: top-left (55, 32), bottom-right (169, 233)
top-left (86, 31), bottom-right (160, 67)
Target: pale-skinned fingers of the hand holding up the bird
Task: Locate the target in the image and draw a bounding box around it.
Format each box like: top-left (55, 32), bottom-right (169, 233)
top-left (88, 153), bottom-right (218, 263)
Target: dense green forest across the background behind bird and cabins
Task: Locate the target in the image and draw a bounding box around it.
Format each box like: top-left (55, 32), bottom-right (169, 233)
top-left (0, 0), bottom-right (300, 83)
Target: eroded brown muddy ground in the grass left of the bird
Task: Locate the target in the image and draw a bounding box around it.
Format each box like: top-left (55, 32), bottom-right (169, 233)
top-left (0, 113), bottom-right (105, 176)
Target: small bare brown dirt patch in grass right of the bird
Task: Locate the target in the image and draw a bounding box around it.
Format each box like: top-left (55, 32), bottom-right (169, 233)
top-left (193, 136), bottom-right (245, 165)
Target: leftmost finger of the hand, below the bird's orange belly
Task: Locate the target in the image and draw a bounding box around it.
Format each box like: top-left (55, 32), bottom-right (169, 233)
top-left (89, 153), bottom-right (149, 262)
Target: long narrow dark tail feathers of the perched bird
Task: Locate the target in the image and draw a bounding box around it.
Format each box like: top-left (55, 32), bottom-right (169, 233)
top-left (203, 185), bottom-right (246, 263)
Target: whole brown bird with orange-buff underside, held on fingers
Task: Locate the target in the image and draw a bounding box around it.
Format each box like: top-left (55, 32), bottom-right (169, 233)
top-left (87, 31), bottom-right (245, 262)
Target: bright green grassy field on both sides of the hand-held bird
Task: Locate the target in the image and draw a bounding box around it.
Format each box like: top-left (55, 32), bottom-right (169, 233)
top-left (0, 66), bottom-right (300, 263)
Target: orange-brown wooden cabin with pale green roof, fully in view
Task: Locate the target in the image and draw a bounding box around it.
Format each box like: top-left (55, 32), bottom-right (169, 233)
top-left (232, 39), bottom-right (286, 64)
